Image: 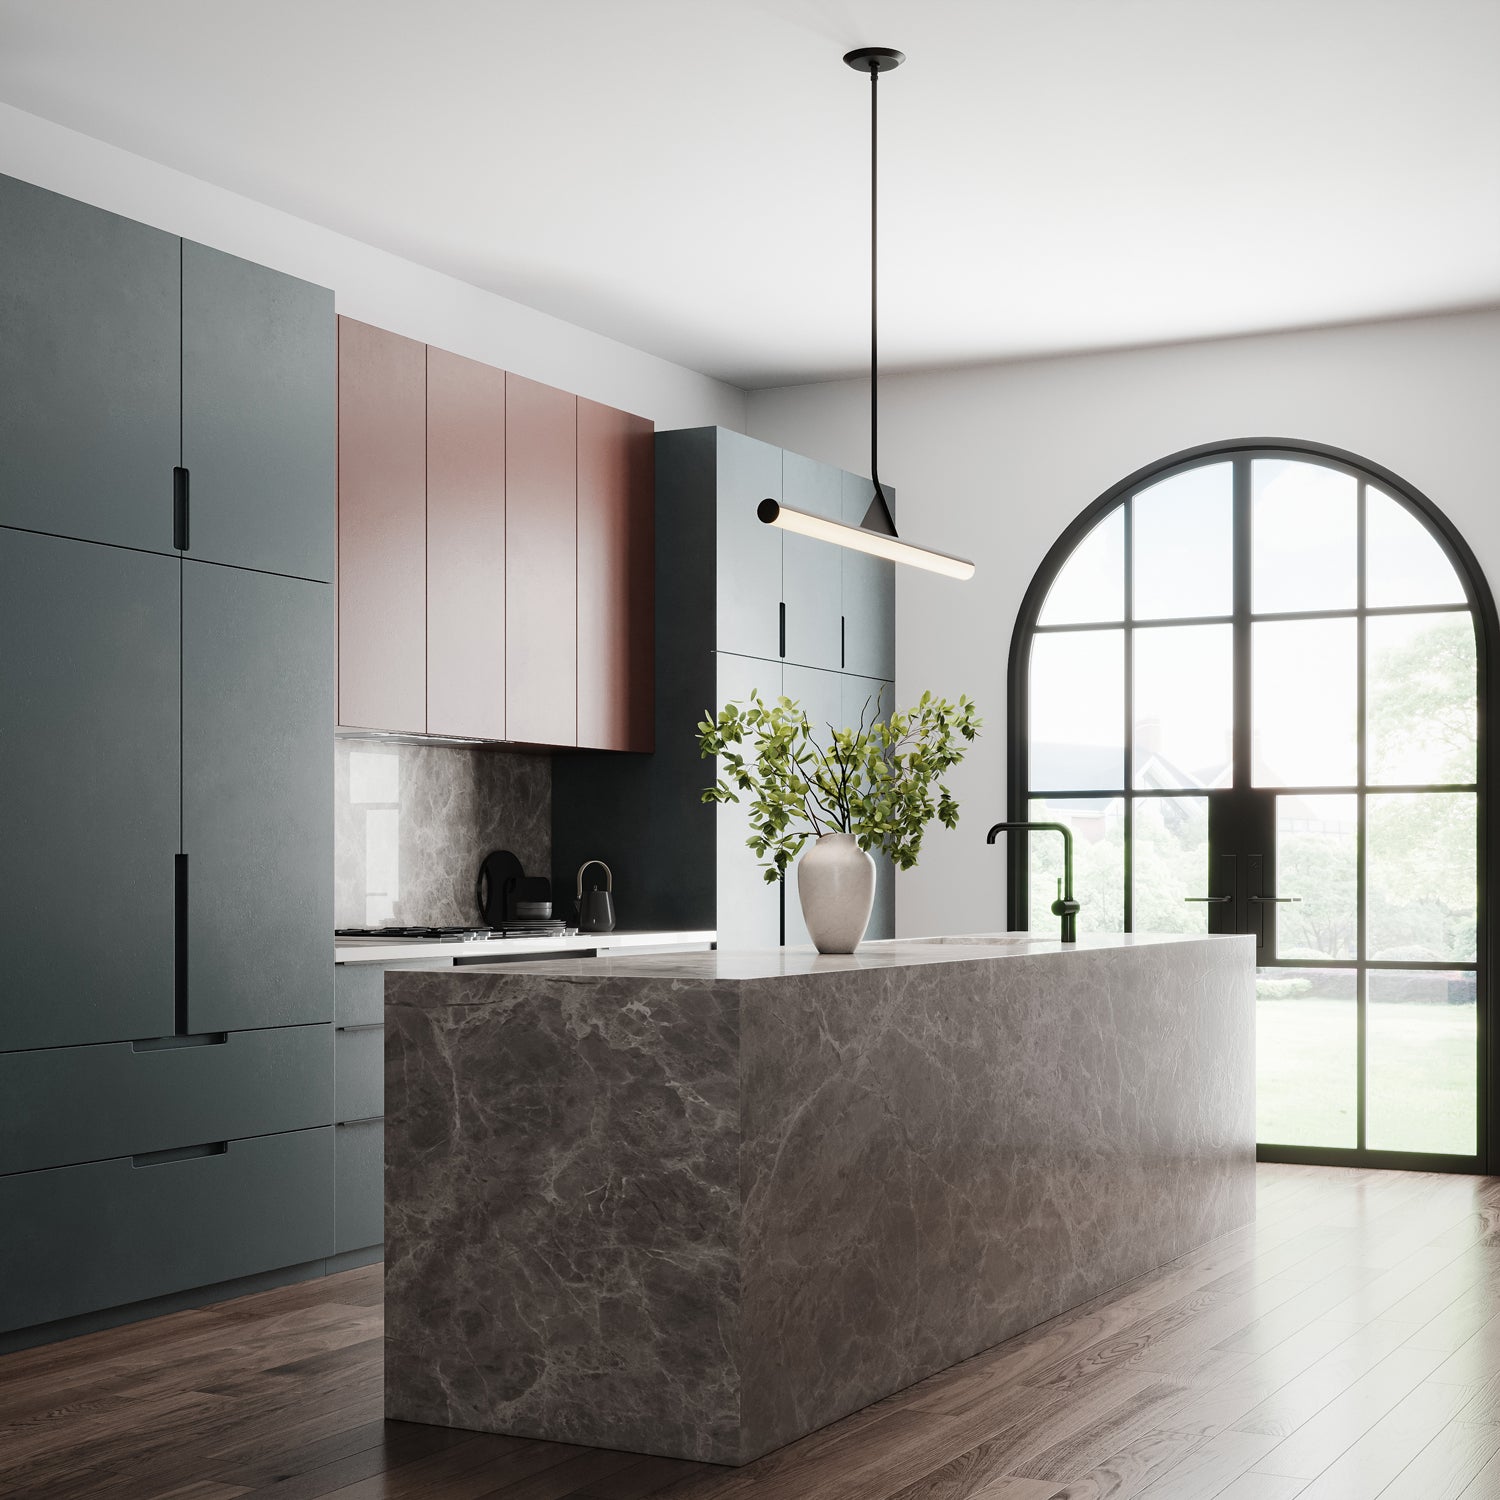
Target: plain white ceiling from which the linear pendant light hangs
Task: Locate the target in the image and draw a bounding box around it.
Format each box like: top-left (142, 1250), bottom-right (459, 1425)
top-left (0, 0), bottom-right (1500, 386)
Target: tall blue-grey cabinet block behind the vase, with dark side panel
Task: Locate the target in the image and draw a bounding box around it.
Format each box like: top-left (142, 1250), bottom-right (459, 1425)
top-left (552, 428), bottom-right (896, 948)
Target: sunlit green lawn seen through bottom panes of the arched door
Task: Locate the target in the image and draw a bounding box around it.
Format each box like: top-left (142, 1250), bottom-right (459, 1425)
top-left (1256, 998), bottom-right (1476, 1157)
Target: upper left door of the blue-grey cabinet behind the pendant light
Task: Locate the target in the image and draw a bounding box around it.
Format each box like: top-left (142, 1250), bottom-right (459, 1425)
top-left (704, 431), bottom-right (783, 669)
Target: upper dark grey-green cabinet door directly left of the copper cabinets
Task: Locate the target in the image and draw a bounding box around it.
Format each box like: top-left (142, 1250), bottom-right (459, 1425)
top-left (182, 240), bottom-right (338, 584)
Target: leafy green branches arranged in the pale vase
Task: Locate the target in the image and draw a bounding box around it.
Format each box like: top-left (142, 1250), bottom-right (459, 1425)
top-left (698, 693), bottom-right (983, 882)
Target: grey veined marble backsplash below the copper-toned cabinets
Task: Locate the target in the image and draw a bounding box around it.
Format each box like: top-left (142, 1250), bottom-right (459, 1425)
top-left (333, 738), bottom-right (552, 927)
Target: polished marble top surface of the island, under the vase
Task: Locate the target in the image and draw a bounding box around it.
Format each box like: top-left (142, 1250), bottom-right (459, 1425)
top-left (426, 933), bottom-right (1244, 984)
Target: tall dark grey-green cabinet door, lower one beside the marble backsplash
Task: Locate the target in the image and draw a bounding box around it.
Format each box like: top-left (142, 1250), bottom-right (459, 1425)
top-left (182, 561), bottom-right (335, 1032)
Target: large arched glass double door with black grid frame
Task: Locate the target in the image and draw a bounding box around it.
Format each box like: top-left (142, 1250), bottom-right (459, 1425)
top-left (1008, 440), bottom-right (1500, 1172)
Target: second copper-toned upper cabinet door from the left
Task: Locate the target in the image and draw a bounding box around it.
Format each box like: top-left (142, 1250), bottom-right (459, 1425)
top-left (428, 347), bottom-right (506, 740)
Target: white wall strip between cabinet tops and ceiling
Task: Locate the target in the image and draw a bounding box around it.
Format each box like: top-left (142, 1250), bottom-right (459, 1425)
top-left (0, 105), bottom-right (746, 429)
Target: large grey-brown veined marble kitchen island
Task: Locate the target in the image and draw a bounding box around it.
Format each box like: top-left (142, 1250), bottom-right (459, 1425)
top-left (386, 936), bottom-right (1254, 1464)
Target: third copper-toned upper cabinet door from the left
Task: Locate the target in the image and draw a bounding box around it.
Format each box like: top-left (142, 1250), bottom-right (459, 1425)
top-left (506, 374), bottom-right (578, 746)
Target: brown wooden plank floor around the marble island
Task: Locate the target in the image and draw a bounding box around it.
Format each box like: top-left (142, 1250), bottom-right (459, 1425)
top-left (0, 1167), bottom-right (1500, 1500)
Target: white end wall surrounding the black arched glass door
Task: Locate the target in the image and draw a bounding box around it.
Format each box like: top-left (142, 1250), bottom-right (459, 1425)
top-left (749, 311), bottom-right (1500, 935)
